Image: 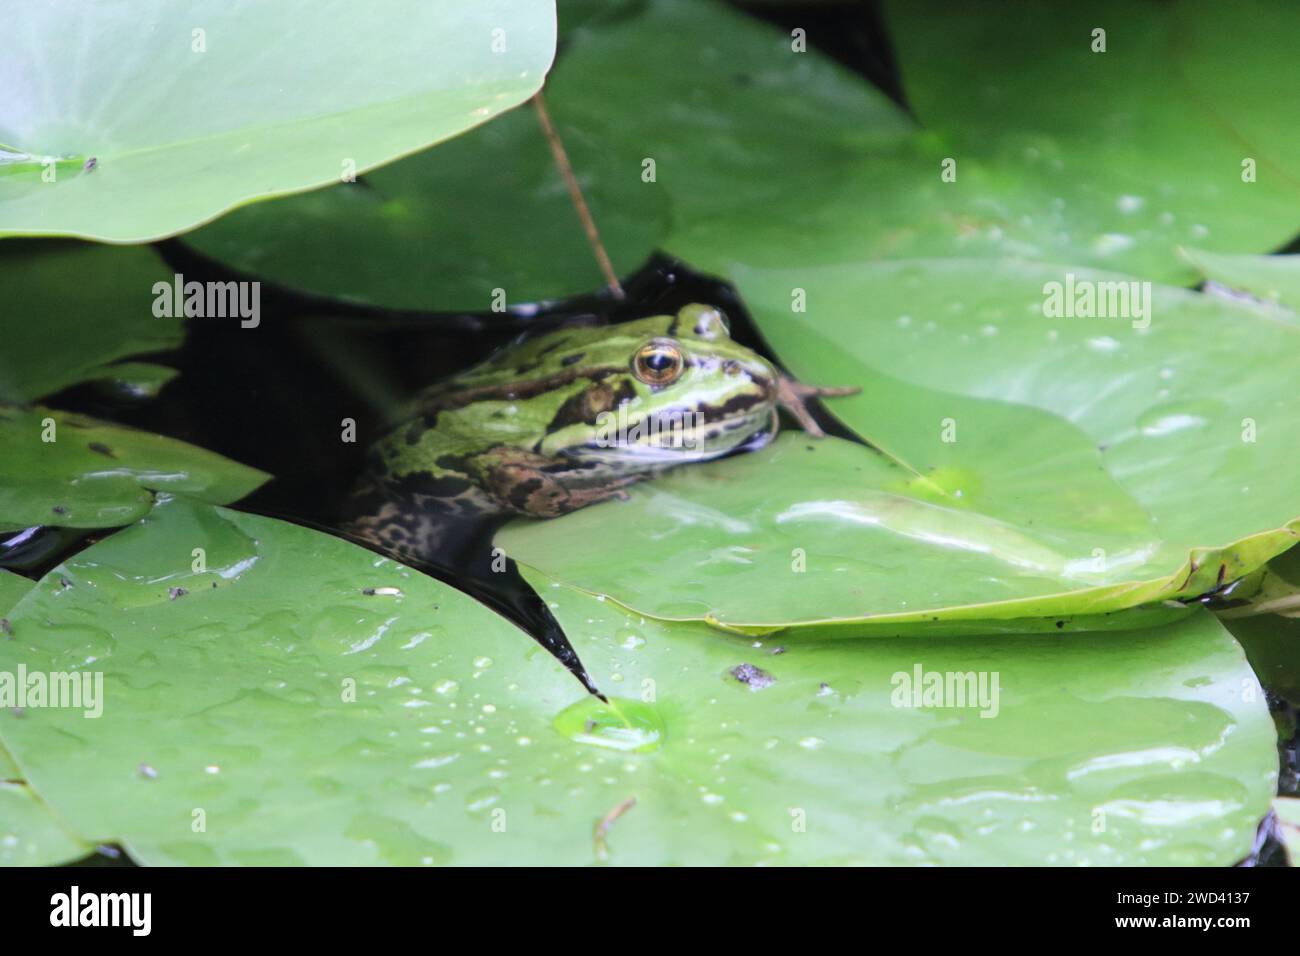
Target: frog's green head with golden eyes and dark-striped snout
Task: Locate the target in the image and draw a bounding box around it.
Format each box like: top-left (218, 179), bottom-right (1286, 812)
top-left (543, 304), bottom-right (777, 471)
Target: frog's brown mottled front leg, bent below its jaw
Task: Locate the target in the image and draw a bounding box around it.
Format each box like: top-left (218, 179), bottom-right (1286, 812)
top-left (469, 445), bottom-right (644, 518)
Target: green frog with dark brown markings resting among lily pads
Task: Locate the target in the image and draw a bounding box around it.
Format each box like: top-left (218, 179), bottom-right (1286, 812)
top-left (350, 304), bottom-right (857, 559)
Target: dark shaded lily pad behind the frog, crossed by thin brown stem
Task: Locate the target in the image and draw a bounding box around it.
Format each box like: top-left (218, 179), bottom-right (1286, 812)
top-left (186, 100), bottom-right (668, 312)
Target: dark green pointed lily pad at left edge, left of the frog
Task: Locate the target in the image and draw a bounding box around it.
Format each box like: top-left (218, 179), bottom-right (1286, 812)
top-left (0, 406), bottom-right (270, 529)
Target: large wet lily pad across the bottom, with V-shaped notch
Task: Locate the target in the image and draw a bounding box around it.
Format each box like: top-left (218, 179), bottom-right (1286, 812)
top-left (0, 501), bottom-right (1275, 865)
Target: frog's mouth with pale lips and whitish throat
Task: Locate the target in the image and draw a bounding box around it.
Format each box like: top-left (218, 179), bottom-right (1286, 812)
top-left (569, 402), bottom-right (779, 471)
